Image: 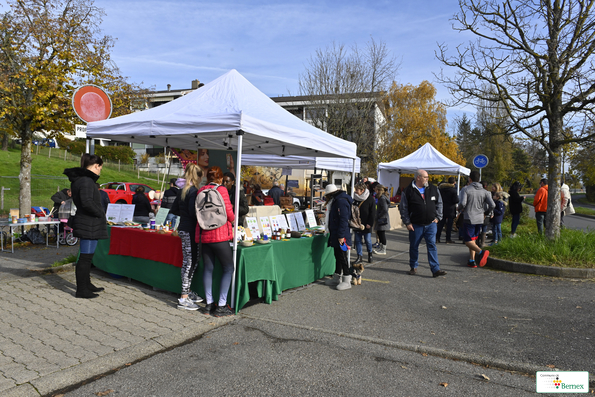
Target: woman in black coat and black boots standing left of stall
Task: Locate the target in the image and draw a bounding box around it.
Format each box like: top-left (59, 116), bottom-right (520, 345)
top-left (64, 153), bottom-right (108, 299)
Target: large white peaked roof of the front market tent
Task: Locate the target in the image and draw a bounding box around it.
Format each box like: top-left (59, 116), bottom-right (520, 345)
top-left (87, 70), bottom-right (357, 159)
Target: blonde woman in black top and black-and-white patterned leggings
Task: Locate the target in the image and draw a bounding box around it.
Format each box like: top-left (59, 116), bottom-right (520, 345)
top-left (171, 163), bottom-right (202, 310)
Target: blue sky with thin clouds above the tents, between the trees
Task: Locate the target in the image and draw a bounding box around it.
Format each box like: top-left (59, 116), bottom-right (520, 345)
top-left (95, 0), bottom-right (472, 124)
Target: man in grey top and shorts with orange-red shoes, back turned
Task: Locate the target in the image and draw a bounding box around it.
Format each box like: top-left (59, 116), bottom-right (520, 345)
top-left (459, 171), bottom-right (496, 267)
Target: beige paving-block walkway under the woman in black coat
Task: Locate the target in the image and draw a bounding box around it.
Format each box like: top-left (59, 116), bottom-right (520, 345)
top-left (0, 247), bottom-right (230, 396)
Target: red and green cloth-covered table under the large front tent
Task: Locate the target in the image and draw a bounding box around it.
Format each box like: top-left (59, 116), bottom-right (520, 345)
top-left (93, 227), bottom-right (335, 313)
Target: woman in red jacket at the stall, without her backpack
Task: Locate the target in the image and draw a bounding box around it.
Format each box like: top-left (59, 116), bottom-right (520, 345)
top-left (196, 166), bottom-right (234, 317)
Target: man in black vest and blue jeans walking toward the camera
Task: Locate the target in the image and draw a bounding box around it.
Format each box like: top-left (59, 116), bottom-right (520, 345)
top-left (400, 170), bottom-right (446, 277)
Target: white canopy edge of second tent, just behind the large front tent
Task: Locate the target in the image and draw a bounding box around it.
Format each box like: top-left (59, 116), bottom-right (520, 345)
top-left (242, 154), bottom-right (360, 173)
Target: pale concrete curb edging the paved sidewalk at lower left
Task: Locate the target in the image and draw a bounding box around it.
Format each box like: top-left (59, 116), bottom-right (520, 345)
top-left (2, 316), bottom-right (235, 397)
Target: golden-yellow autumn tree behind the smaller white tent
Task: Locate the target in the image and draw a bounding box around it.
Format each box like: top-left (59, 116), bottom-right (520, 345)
top-left (378, 80), bottom-right (465, 166)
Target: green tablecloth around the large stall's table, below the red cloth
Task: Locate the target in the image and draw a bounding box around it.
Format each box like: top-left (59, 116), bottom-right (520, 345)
top-left (93, 229), bottom-right (335, 313)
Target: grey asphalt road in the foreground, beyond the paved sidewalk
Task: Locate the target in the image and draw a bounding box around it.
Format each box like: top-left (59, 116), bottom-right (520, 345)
top-left (59, 230), bottom-right (595, 396)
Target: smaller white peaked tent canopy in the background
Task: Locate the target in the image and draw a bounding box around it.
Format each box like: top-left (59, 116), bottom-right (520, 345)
top-left (378, 143), bottom-right (471, 191)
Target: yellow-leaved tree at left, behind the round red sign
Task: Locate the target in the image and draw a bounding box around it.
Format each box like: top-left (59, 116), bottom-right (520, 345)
top-left (0, 0), bottom-right (148, 217)
